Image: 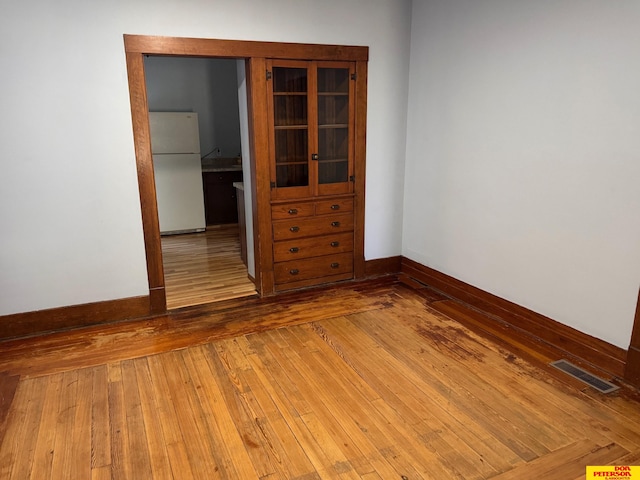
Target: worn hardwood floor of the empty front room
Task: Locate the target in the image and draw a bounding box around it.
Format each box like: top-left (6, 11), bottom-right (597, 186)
top-left (0, 278), bottom-right (640, 480)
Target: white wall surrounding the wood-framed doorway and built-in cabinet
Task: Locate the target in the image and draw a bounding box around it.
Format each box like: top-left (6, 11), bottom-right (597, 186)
top-left (0, 0), bottom-right (411, 315)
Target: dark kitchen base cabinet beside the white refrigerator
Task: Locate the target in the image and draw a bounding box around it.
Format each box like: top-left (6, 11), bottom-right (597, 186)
top-left (202, 171), bottom-right (242, 225)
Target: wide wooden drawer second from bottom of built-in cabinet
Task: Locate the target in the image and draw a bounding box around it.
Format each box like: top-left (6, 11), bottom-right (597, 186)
top-left (273, 232), bottom-right (353, 262)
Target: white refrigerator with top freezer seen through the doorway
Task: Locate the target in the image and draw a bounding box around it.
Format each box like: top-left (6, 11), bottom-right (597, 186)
top-left (149, 112), bottom-right (206, 235)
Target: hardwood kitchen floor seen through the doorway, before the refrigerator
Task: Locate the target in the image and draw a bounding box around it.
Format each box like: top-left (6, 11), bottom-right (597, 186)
top-left (162, 224), bottom-right (256, 309)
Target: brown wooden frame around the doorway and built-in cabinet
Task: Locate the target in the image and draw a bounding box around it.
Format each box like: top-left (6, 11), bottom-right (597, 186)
top-left (124, 35), bottom-right (369, 313)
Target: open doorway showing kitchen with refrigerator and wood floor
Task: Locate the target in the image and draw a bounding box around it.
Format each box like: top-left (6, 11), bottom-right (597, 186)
top-left (144, 55), bottom-right (256, 310)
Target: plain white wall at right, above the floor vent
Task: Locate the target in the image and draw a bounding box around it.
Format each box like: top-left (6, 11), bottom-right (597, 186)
top-left (403, 0), bottom-right (640, 348)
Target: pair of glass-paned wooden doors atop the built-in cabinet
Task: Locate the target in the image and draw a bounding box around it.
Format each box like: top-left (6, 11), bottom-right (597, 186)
top-left (268, 60), bottom-right (355, 199)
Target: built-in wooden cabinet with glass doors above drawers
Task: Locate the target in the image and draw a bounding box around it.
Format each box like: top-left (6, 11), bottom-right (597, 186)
top-left (267, 60), bottom-right (356, 291)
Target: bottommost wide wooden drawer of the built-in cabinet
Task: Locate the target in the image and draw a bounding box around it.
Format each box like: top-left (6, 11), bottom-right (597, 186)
top-left (274, 253), bottom-right (353, 284)
